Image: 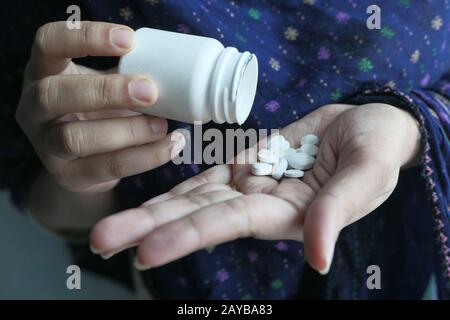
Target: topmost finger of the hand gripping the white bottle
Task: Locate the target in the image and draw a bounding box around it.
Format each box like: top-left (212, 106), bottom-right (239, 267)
top-left (30, 21), bottom-right (134, 79)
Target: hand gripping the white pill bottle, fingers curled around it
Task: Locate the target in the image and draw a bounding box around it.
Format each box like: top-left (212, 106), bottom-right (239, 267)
top-left (16, 22), bottom-right (184, 192)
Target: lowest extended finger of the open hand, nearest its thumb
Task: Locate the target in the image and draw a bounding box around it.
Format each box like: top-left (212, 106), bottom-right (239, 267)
top-left (135, 194), bottom-right (303, 270)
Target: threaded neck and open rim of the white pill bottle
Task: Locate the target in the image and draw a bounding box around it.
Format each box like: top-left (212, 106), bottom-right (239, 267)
top-left (209, 47), bottom-right (258, 125)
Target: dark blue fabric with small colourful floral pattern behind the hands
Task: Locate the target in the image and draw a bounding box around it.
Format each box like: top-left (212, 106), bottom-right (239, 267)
top-left (0, 0), bottom-right (450, 299)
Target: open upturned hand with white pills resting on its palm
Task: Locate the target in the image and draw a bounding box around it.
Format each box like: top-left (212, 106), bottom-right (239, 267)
top-left (91, 104), bottom-right (420, 274)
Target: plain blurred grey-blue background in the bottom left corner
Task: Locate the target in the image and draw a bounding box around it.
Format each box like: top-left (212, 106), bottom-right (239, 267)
top-left (0, 192), bottom-right (134, 299)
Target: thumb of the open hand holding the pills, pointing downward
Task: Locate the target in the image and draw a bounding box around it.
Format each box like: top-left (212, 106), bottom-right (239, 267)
top-left (304, 160), bottom-right (398, 274)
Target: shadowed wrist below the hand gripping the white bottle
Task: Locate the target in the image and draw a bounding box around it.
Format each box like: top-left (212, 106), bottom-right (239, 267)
top-left (27, 171), bottom-right (117, 238)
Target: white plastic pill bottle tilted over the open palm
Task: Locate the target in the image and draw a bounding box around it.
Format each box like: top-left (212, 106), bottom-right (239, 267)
top-left (119, 28), bottom-right (258, 125)
